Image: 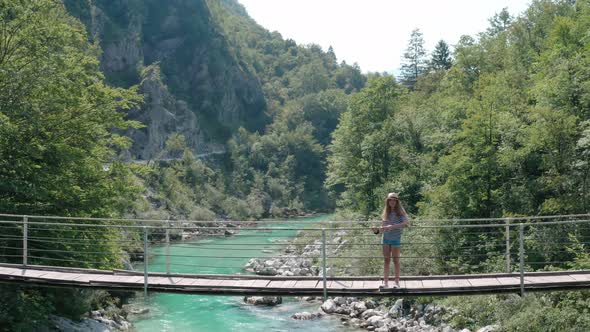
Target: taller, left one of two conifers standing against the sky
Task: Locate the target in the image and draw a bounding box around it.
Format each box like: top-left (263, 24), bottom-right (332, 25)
top-left (401, 29), bottom-right (427, 90)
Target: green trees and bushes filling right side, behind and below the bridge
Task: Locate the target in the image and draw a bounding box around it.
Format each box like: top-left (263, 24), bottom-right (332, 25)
top-left (326, 0), bottom-right (590, 331)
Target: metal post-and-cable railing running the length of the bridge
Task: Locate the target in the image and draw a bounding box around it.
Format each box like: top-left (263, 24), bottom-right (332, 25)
top-left (0, 214), bottom-right (590, 292)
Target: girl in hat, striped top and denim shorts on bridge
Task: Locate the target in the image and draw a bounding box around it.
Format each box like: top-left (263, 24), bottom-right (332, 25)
top-left (379, 193), bottom-right (409, 288)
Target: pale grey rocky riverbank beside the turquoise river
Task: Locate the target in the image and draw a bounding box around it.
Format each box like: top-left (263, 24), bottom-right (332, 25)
top-left (244, 231), bottom-right (499, 332)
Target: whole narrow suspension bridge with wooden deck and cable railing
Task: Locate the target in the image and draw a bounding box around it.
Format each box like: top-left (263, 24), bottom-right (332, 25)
top-left (0, 214), bottom-right (590, 297)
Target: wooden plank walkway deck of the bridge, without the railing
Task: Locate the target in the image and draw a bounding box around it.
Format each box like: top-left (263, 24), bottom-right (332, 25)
top-left (0, 264), bottom-right (590, 296)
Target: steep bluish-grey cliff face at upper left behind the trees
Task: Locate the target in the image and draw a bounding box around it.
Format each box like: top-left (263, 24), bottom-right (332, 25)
top-left (65, 0), bottom-right (268, 159)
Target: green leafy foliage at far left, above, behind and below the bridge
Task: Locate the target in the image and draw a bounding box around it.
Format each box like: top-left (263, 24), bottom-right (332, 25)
top-left (0, 0), bottom-right (141, 330)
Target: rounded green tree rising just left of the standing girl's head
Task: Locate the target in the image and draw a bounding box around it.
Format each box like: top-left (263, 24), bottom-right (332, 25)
top-left (326, 76), bottom-right (401, 215)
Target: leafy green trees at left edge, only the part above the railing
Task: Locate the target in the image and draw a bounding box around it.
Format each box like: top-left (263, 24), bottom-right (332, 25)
top-left (0, 0), bottom-right (139, 215)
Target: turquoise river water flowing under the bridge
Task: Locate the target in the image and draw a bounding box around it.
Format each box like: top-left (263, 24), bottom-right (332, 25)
top-left (129, 216), bottom-right (358, 332)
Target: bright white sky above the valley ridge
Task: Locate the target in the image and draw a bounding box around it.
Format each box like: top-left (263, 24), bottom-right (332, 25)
top-left (238, 0), bottom-right (531, 72)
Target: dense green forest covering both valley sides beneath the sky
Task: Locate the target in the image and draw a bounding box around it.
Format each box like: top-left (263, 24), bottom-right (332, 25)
top-left (0, 0), bottom-right (590, 331)
